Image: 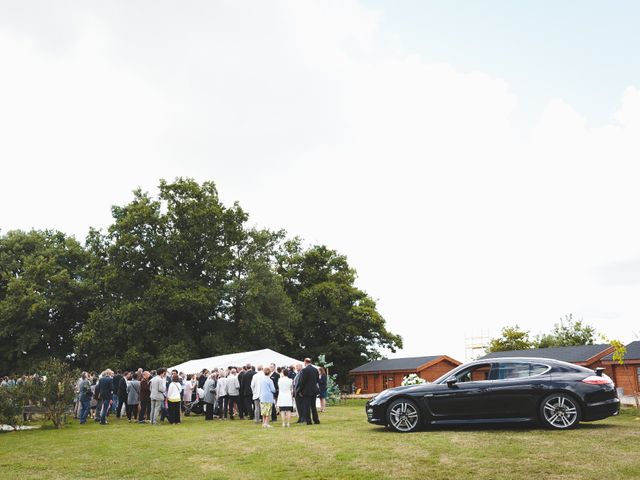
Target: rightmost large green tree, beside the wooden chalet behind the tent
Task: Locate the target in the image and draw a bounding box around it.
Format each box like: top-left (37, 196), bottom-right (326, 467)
top-left (279, 240), bottom-right (402, 380)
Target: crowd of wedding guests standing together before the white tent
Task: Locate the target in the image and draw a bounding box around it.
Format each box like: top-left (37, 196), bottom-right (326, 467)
top-left (75, 358), bottom-right (327, 428)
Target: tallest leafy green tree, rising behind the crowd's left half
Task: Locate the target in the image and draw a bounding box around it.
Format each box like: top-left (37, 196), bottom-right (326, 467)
top-left (78, 179), bottom-right (247, 368)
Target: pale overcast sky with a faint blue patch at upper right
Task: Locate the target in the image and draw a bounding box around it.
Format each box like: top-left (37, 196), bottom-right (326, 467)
top-left (0, 0), bottom-right (640, 360)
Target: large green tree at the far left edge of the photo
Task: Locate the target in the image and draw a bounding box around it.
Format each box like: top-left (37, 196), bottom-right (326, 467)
top-left (0, 230), bottom-right (94, 372)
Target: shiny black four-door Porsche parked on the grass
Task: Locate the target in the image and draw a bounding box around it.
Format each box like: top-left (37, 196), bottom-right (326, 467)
top-left (366, 358), bottom-right (620, 432)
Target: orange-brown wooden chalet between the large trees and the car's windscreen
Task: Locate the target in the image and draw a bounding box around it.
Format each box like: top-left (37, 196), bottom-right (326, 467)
top-left (349, 355), bottom-right (462, 394)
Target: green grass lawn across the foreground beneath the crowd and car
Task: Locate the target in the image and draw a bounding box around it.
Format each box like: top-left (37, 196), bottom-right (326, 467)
top-left (0, 401), bottom-right (640, 480)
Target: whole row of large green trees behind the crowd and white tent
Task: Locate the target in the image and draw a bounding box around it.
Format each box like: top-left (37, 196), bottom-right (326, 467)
top-left (0, 178), bottom-right (402, 379)
